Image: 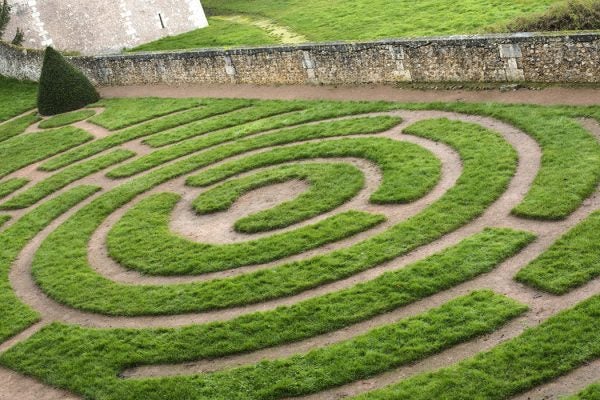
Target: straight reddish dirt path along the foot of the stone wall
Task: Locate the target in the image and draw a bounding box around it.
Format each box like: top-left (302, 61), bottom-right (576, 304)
top-left (100, 84), bottom-right (600, 105)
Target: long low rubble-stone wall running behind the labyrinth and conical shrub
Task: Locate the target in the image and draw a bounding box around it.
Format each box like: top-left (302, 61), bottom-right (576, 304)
top-left (0, 33), bottom-right (600, 85)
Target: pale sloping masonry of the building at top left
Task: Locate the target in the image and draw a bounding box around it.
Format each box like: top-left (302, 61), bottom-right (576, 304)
top-left (6, 0), bottom-right (208, 54)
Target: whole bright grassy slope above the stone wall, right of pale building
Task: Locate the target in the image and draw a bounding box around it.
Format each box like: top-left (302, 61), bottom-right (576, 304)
top-left (138, 0), bottom-right (556, 50)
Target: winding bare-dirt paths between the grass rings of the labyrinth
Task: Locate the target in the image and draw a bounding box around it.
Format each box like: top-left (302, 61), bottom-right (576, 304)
top-left (0, 105), bottom-right (600, 400)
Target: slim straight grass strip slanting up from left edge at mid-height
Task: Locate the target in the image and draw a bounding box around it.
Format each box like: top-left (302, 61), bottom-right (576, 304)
top-left (0, 149), bottom-right (135, 210)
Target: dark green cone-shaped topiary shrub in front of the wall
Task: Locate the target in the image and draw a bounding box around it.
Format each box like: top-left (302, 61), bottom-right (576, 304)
top-left (38, 47), bottom-right (100, 115)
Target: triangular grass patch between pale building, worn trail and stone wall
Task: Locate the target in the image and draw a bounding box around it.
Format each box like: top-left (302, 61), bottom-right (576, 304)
top-left (130, 17), bottom-right (277, 51)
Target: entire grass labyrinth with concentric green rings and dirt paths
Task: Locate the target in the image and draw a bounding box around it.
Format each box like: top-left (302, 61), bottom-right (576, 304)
top-left (0, 82), bottom-right (600, 400)
